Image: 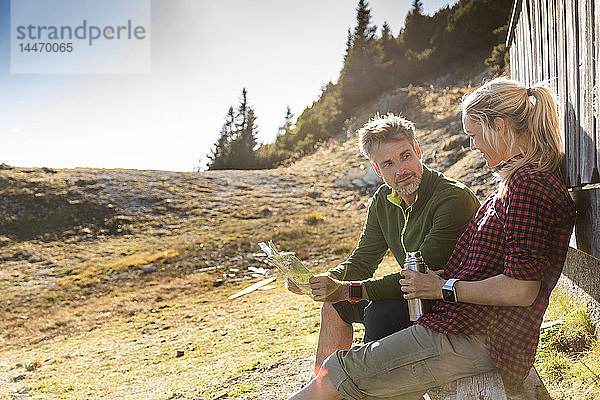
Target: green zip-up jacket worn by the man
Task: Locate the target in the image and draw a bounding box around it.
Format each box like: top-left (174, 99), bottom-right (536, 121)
top-left (330, 166), bottom-right (480, 300)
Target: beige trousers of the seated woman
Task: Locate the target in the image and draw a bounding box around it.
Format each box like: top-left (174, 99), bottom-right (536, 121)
top-left (322, 325), bottom-right (495, 400)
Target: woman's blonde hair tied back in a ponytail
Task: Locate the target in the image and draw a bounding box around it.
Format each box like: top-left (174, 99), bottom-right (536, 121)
top-left (462, 78), bottom-right (563, 181)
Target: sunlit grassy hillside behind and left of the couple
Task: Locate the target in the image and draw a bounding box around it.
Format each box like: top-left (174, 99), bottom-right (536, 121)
top-left (0, 85), bottom-right (494, 399)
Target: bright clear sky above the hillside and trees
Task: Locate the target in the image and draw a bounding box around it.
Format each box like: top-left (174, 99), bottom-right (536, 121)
top-left (0, 0), bottom-right (456, 171)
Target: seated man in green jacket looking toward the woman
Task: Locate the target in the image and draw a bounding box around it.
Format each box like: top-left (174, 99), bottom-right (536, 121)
top-left (288, 114), bottom-right (479, 375)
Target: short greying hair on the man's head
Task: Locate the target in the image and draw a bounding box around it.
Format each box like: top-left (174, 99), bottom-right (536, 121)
top-left (358, 113), bottom-right (416, 160)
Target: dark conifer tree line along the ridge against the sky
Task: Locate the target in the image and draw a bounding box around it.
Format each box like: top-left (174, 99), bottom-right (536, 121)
top-left (207, 0), bottom-right (513, 169)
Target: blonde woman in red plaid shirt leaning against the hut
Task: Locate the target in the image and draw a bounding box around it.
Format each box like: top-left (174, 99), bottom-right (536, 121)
top-left (291, 79), bottom-right (575, 400)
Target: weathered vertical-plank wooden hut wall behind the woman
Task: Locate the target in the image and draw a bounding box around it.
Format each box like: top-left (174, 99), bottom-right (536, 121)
top-left (508, 0), bottom-right (600, 258)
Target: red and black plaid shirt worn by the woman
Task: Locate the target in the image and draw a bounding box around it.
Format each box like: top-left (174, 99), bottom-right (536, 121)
top-left (417, 164), bottom-right (575, 384)
